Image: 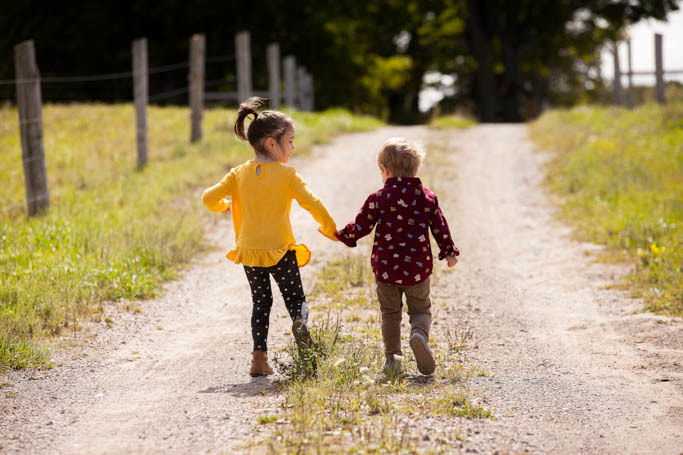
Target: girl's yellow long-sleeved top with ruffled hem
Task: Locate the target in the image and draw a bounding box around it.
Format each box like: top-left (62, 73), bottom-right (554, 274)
top-left (202, 160), bottom-right (337, 267)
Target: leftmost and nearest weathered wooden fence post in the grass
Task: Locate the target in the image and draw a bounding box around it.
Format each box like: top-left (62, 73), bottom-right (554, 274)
top-left (14, 41), bottom-right (50, 215)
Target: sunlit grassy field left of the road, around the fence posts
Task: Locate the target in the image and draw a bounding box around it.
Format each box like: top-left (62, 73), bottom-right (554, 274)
top-left (0, 104), bottom-right (379, 370)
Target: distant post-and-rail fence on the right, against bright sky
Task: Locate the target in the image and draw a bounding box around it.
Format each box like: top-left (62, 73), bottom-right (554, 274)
top-left (612, 33), bottom-right (683, 107)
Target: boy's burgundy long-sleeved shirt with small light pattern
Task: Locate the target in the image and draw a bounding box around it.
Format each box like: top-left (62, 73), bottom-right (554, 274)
top-left (336, 177), bottom-right (460, 286)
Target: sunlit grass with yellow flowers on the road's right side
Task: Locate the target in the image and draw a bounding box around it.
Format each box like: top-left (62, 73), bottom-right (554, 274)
top-left (531, 104), bottom-right (683, 317)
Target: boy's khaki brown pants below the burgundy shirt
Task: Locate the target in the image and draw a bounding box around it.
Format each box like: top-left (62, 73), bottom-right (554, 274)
top-left (375, 278), bottom-right (432, 355)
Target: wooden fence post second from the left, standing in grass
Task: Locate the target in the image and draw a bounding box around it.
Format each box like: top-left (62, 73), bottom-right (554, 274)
top-left (133, 38), bottom-right (149, 167)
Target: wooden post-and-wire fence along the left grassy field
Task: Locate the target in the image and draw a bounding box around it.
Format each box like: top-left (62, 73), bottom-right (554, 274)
top-left (0, 31), bottom-right (315, 215)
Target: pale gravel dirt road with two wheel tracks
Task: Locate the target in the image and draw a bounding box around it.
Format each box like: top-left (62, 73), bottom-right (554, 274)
top-left (0, 125), bottom-right (683, 454)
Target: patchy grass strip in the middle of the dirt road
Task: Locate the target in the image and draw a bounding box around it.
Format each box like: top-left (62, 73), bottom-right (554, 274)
top-left (258, 254), bottom-right (494, 453)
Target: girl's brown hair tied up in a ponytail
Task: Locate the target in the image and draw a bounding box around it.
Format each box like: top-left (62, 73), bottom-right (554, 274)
top-left (235, 96), bottom-right (294, 156)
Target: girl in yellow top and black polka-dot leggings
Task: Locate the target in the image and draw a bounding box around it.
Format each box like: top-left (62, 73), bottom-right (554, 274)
top-left (202, 97), bottom-right (336, 376)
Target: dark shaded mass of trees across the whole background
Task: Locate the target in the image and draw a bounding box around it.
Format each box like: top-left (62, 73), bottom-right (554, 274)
top-left (0, 0), bottom-right (678, 123)
